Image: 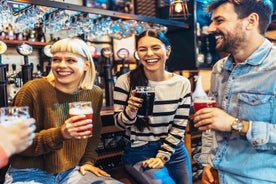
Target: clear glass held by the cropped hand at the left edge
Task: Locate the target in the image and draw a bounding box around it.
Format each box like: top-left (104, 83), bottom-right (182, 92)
top-left (0, 106), bottom-right (30, 126)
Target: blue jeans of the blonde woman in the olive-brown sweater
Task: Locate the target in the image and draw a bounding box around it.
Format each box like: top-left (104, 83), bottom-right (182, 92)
top-left (5, 166), bottom-right (122, 184)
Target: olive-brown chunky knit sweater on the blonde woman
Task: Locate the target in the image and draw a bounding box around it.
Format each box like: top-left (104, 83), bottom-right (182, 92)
top-left (11, 78), bottom-right (103, 173)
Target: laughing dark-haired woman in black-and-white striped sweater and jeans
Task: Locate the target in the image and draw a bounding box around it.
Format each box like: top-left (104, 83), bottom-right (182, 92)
top-left (114, 30), bottom-right (192, 184)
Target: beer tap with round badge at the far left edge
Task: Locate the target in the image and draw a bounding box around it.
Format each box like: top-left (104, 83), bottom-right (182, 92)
top-left (0, 41), bottom-right (8, 107)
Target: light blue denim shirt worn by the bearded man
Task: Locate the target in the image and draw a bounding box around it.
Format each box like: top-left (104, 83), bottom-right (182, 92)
top-left (202, 39), bottom-right (276, 184)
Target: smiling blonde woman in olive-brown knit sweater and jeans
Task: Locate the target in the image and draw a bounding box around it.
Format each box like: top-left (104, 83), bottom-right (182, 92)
top-left (5, 38), bottom-right (120, 184)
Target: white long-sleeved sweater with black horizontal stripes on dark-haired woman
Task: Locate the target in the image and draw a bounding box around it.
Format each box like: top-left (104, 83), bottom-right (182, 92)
top-left (114, 74), bottom-right (191, 161)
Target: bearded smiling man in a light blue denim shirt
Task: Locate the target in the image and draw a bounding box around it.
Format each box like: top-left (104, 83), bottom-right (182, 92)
top-left (194, 0), bottom-right (276, 184)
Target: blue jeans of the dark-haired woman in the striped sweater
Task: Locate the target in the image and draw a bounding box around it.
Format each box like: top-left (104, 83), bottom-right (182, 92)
top-left (123, 141), bottom-right (192, 184)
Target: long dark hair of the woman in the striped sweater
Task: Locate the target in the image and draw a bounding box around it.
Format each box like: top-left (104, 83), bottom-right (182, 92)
top-left (129, 30), bottom-right (171, 131)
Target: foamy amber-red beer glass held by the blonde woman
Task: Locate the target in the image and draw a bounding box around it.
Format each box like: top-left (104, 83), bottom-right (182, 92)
top-left (69, 101), bottom-right (93, 139)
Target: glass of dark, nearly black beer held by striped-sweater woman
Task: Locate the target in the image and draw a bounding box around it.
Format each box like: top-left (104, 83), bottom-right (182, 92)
top-left (136, 86), bottom-right (155, 118)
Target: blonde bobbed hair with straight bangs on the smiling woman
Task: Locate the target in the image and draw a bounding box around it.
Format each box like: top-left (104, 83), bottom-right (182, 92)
top-left (46, 37), bottom-right (96, 89)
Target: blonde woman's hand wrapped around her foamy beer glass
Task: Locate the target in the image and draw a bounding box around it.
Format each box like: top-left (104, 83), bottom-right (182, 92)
top-left (61, 115), bottom-right (93, 139)
